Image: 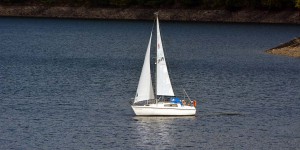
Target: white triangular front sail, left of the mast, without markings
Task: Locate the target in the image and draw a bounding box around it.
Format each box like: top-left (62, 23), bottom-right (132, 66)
top-left (134, 32), bottom-right (154, 103)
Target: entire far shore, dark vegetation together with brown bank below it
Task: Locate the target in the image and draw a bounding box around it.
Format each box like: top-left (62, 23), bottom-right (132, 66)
top-left (0, 0), bottom-right (300, 24)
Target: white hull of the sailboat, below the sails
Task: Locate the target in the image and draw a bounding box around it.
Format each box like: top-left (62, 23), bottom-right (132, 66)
top-left (131, 103), bottom-right (196, 116)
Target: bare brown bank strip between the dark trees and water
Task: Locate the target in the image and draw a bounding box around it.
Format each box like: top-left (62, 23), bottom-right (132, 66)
top-left (0, 6), bottom-right (300, 24)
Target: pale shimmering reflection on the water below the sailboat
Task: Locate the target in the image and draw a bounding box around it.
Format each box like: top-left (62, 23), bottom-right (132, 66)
top-left (133, 116), bottom-right (195, 149)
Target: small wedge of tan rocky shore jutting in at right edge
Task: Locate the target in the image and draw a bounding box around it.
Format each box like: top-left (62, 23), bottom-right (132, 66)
top-left (266, 37), bottom-right (300, 58)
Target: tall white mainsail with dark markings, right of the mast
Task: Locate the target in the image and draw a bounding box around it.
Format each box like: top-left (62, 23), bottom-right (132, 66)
top-left (156, 16), bottom-right (174, 96)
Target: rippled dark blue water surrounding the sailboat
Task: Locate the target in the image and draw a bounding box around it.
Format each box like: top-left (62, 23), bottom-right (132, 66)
top-left (0, 18), bottom-right (300, 150)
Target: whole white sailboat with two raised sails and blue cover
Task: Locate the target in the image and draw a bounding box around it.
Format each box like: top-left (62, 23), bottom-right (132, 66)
top-left (131, 13), bottom-right (196, 116)
